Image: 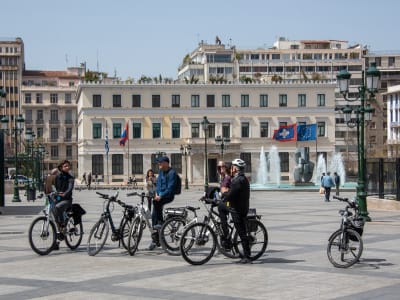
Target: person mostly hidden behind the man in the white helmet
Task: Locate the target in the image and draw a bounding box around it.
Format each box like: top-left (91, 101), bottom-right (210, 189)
top-left (217, 161), bottom-right (232, 251)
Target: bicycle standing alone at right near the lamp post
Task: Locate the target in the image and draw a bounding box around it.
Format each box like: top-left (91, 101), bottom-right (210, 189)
top-left (327, 196), bottom-right (364, 268)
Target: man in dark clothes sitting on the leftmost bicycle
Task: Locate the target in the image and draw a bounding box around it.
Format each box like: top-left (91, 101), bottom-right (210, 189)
top-left (55, 160), bottom-right (75, 227)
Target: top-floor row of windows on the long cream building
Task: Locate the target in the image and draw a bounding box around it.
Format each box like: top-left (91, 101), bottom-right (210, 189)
top-left (92, 94), bottom-right (326, 107)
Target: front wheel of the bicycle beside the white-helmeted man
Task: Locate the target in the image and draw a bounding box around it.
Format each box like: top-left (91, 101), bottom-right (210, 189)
top-left (180, 223), bottom-right (217, 265)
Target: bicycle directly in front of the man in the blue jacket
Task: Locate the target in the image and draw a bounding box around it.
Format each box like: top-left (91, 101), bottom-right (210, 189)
top-left (126, 192), bottom-right (157, 255)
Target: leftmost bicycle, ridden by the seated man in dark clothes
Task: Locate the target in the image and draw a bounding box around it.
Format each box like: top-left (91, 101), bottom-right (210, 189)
top-left (28, 192), bottom-right (86, 255)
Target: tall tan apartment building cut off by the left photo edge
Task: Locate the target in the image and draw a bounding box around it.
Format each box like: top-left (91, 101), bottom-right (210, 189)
top-left (0, 37), bottom-right (25, 157)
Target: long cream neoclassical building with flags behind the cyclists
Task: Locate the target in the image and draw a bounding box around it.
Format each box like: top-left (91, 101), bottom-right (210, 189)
top-left (77, 80), bottom-right (335, 184)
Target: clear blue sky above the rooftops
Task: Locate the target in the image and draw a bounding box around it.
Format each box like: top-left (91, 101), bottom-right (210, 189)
top-left (0, 0), bottom-right (400, 79)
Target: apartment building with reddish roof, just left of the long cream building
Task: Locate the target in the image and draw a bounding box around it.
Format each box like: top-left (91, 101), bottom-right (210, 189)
top-left (21, 67), bottom-right (84, 174)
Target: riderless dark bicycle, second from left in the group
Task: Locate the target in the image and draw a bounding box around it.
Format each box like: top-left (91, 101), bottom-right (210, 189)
top-left (87, 192), bottom-right (135, 256)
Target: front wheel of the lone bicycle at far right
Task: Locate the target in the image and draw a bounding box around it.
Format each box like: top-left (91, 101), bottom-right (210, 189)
top-left (327, 229), bottom-right (363, 268)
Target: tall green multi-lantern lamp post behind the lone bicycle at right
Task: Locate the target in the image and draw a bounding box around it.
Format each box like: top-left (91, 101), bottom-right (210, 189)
top-left (336, 63), bottom-right (380, 221)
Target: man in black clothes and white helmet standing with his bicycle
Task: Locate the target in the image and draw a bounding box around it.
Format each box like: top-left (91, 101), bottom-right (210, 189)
top-left (224, 158), bottom-right (251, 264)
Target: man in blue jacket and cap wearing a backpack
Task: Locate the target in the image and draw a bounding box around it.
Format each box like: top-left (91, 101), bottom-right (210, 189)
top-left (149, 156), bottom-right (177, 250)
